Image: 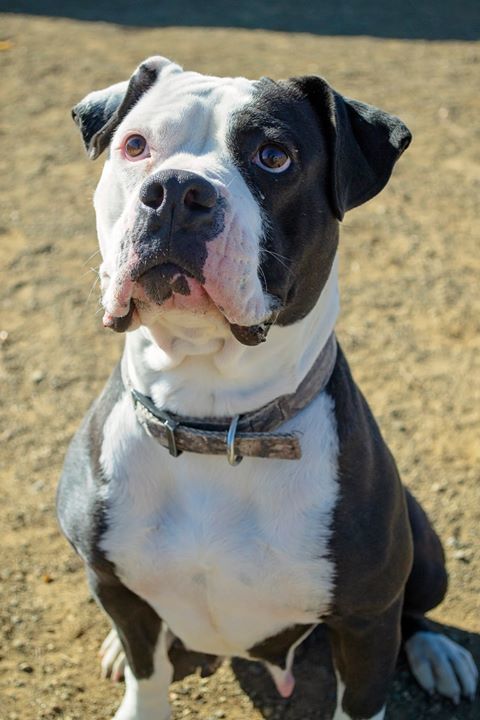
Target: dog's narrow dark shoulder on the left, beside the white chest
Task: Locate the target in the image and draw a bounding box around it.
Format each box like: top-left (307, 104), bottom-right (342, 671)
top-left (57, 364), bottom-right (125, 565)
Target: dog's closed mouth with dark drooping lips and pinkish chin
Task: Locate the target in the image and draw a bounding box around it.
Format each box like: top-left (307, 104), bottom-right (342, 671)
top-left (103, 262), bottom-right (278, 346)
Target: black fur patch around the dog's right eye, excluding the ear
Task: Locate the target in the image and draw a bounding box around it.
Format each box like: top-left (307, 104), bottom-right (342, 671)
top-left (227, 79), bottom-right (338, 325)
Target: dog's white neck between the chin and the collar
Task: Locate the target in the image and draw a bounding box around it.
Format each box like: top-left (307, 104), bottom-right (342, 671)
top-left (122, 261), bottom-right (339, 417)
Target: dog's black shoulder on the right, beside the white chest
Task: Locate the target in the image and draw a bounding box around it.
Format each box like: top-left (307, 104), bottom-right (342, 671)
top-left (326, 347), bottom-right (412, 615)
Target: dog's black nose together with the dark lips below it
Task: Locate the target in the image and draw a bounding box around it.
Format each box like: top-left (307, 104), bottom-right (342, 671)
top-left (104, 169), bottom-right (278, 345)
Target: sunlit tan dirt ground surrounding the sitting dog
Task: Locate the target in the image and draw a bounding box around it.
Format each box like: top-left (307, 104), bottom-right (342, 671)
top-left (0, 7), bottom-right (480, 720)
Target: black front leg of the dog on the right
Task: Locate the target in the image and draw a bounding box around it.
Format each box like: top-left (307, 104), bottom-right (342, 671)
top-left (327, 602), bottom-right (402, 720)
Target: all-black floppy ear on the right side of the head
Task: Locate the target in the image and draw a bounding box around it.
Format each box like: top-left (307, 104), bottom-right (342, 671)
top-left (296, 76), bottom-right (412, 220)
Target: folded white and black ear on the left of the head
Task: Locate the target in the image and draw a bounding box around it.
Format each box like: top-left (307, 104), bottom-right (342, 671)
top-left (72, 55), bottom-right (181, 160)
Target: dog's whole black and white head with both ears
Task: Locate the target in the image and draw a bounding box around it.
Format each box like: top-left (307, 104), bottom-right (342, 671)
top-left (73, 57), bottom-right (410, 345)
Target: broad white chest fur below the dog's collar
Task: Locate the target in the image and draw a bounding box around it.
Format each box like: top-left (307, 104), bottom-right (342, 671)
top-left (101, 393), bottom-right (338, 656)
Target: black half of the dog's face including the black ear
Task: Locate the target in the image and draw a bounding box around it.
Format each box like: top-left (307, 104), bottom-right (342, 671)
top-left (227, 77), bottom-right (410, 325)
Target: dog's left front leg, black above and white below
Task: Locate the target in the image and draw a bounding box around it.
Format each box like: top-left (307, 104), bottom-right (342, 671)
top-left (88, 563), bottom-right (173, 720)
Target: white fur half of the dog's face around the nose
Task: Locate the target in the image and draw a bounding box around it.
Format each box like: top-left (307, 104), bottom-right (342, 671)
top-left (95, 61), bottom-right (272, 326)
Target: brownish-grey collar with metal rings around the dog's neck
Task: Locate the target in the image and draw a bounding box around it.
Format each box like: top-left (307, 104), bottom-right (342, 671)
top-left (127, 333), bottom-right (337, 465)
